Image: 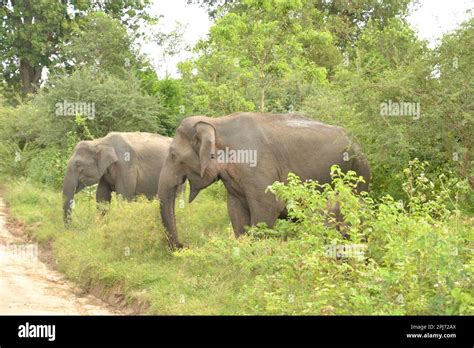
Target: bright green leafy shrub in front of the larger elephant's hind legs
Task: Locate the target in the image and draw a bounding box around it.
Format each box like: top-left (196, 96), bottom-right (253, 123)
top-left (178, 160), bottom-right (474, 315)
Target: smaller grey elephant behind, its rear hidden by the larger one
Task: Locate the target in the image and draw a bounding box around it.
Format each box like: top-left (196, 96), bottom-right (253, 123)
top-left (63, 132), bottom-right (180, 223)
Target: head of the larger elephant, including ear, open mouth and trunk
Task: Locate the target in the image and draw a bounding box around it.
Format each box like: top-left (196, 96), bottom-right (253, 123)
top-left (158, 116), bottom-right (219, 248)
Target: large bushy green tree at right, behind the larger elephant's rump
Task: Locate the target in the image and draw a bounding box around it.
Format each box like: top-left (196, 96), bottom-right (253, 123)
top-left (303, 20), bottom-right (474, 204)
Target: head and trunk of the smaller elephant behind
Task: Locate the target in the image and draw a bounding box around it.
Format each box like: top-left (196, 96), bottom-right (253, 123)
top-left (63, 140), bottom-right (118, 223)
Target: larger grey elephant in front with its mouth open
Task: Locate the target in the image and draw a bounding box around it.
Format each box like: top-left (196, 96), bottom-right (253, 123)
top-left (158, 113), bottom-right (370, 248)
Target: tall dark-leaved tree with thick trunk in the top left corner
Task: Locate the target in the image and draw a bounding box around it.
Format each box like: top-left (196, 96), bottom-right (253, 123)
top-left (0, 0), bottom-right (152, 95)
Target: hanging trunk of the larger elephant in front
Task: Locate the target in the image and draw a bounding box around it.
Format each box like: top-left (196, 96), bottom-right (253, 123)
top-left (158, 165), bottom-right (183, 249)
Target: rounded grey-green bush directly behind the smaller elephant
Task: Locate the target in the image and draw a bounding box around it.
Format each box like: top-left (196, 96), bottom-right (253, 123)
top-left (37, 67), bottom-right (167, 139)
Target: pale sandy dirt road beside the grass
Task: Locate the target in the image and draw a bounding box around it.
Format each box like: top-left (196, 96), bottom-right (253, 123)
top-left (0, 197), bottom-right (120, 315)
